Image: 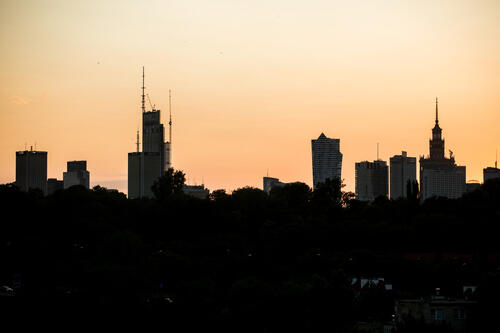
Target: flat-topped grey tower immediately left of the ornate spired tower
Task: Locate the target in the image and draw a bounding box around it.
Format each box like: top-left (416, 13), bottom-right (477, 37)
top-left (389, 151), bottom-right (417, 199)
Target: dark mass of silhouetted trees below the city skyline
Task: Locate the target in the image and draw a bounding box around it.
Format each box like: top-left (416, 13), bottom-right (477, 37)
top-left (0, 176), bottom-right (500, 332)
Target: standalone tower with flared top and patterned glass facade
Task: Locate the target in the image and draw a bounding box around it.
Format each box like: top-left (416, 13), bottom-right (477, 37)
top-left (311, 133), bottom-right (342, 189)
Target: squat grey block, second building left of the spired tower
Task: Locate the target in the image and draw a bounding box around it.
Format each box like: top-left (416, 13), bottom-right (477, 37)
top-left (355, 160), bottom-right (389, 201)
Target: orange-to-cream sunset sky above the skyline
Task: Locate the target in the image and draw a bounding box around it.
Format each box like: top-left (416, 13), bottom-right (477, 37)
top-left (0, 0), bottom-right (500, 192)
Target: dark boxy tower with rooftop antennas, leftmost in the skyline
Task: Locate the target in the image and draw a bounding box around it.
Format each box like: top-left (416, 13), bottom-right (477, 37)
top-left (16, 147), bottom-right (47, 194)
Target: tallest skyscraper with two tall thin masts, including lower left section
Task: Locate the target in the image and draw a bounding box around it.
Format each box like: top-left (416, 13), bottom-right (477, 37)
top-left (128, 67), bottom-right (172, 198)
